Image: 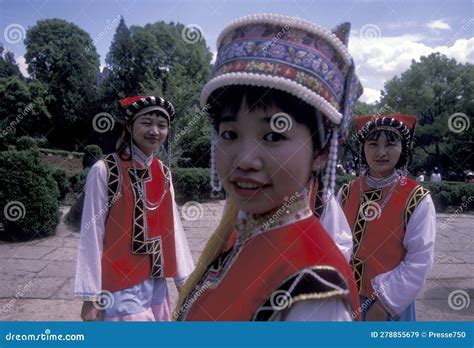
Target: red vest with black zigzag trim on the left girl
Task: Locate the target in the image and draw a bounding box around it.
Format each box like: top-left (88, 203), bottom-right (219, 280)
top-left (102, 154), bottom-right (176, 291)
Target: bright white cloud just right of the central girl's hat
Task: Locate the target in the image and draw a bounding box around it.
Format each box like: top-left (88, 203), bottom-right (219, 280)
top-left (349, 35), bottom-right (474, 103)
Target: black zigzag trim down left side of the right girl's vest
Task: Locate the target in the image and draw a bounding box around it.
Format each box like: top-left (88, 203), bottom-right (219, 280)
top-left (351, 189), bottom-right (382, 292)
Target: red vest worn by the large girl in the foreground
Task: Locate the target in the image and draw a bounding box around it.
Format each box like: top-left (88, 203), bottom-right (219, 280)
top-left (179, 216), bottom-right (359, 321)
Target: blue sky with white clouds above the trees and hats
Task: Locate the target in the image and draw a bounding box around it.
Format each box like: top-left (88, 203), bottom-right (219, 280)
top-left (0, 0), bottom-right (474, 102)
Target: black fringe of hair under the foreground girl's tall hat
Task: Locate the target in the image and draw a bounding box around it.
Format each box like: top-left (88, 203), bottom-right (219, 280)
top-left (208, 86), bottom-right (329, 150)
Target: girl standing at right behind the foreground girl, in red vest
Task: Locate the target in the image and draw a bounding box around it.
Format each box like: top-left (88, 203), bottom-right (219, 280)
top-left (338, 115), bottom-right (436, 321)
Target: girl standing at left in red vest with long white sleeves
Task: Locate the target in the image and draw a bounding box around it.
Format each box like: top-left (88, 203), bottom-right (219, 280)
top-left (74, 96), bottom-right (194, 321)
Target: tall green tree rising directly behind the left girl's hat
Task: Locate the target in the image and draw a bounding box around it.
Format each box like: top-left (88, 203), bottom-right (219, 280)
top-left (101, 20), bottom-right (212, 167)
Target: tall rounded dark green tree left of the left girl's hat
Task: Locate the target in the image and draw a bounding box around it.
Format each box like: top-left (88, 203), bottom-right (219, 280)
top-left (25, 19), bottom-right (99, 149)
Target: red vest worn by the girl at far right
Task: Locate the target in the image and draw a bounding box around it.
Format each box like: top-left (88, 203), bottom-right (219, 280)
top-left (341, 178), bottom-right (429, 297)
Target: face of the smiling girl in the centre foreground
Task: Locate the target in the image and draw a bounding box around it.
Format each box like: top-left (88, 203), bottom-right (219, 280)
top-left (216, 100), bottom-right (320, 214)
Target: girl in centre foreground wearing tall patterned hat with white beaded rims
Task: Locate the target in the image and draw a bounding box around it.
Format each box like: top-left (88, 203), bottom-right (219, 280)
top-left (174, 15), bottom-right (362, 321)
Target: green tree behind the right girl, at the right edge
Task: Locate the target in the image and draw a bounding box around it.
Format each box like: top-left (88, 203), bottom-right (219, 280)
top-left (380, 53), bottom-right (474, 177)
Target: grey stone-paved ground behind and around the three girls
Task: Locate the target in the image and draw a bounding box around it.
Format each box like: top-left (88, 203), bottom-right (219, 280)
top-left (0, 202), bottom-right (474, 321)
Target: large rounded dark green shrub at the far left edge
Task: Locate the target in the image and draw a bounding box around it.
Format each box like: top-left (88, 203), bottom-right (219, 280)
top-left (0, 149), bottom-right (59, 241)
